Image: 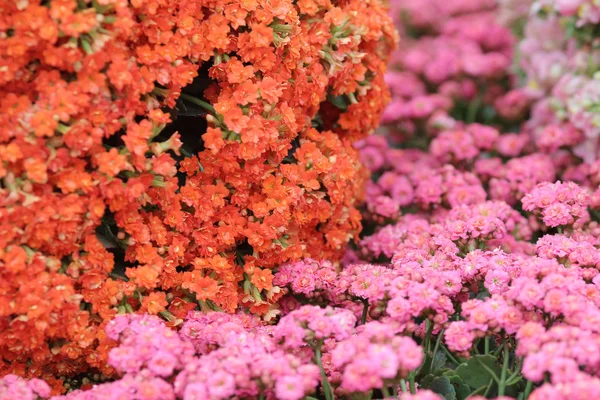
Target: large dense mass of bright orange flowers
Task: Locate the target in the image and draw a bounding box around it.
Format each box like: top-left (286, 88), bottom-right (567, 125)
top-left (0, 0), bottom-right (396, 387)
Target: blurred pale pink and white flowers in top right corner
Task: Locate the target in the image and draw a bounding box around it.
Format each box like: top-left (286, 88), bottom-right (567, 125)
top-left (518, 0), bottom-right (600, 162)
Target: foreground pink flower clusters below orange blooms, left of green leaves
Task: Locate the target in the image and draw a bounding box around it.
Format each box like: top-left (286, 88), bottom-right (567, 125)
top-left (0, 312), bottom-right (422, 400)
